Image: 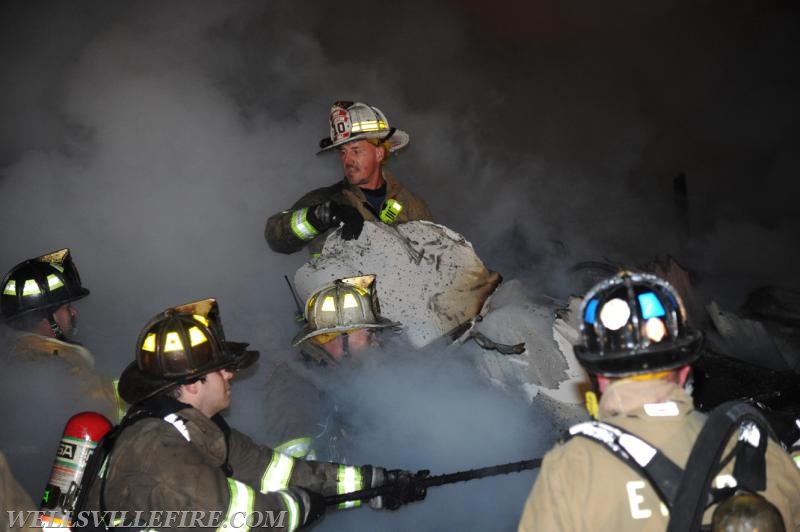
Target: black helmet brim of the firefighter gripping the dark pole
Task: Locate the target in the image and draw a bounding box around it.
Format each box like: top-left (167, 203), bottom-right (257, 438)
top-left (118, 342), bottom-right (259, 405)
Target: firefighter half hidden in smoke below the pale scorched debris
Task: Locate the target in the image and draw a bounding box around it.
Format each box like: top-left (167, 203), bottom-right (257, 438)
top-left (266, 275), bottom-right (400, 461)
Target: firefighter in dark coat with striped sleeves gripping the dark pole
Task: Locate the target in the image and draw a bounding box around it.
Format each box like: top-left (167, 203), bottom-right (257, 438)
top-left (85, 299), bottom-right (424, 530)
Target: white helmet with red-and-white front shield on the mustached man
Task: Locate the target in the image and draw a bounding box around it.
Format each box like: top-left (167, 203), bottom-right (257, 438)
top-left (318, 101), bottom-right (410, 153)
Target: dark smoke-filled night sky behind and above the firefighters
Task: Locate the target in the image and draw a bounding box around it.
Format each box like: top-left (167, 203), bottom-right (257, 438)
top-left (0, 0), bottom-right (800, 528)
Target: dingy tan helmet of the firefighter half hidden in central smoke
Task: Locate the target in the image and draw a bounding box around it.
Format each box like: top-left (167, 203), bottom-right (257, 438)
top-left (292, 275), bottom-right (400, 345)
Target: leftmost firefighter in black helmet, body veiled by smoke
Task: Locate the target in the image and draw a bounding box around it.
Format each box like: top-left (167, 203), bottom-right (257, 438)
top-left (0, 248), bottom-right (124, 497)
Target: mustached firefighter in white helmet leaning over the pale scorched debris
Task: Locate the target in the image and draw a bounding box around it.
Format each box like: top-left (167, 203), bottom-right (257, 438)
top-left (264, 101), bottom-right (433, 253)
